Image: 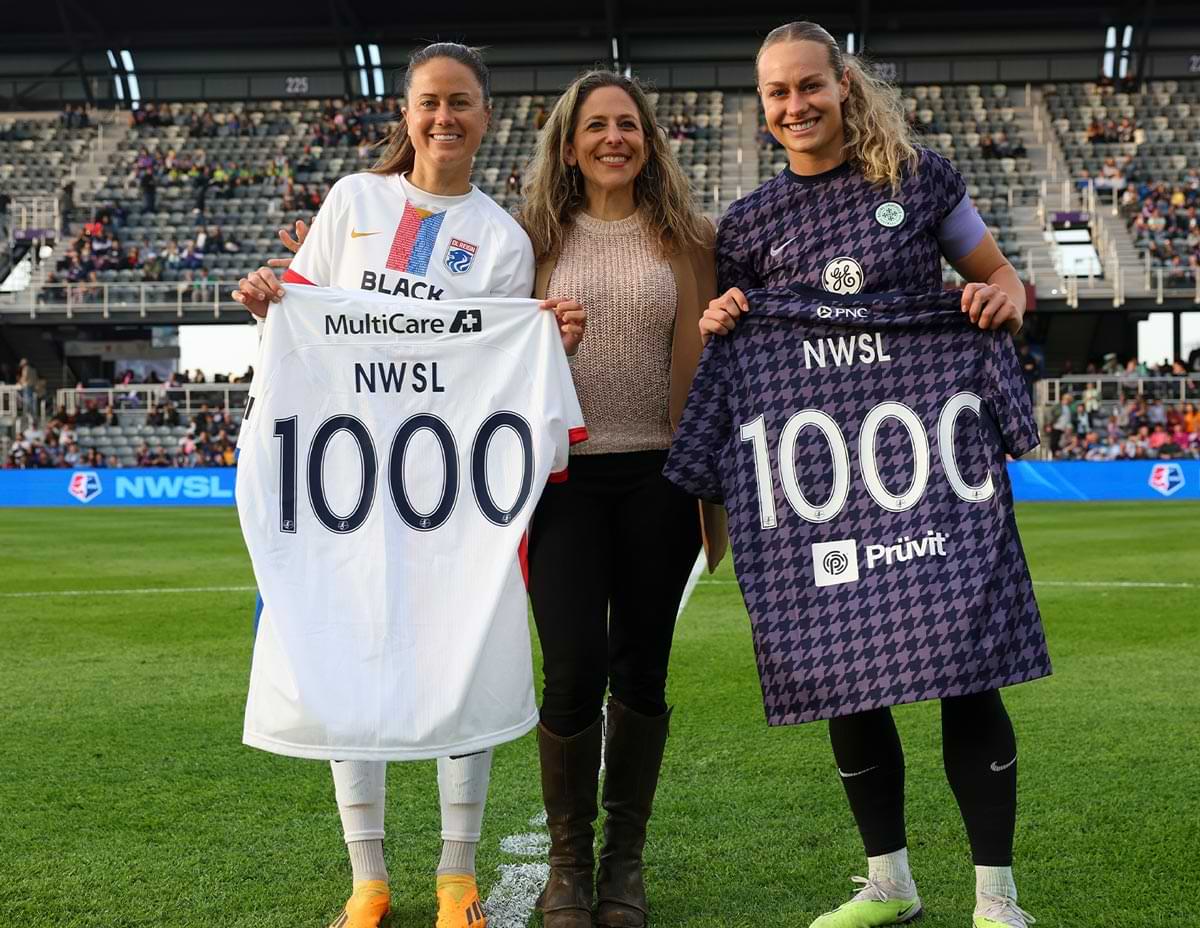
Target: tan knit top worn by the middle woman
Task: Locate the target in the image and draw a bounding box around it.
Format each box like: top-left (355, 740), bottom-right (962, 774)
top-left (546, 212), bottom-right (678, 454)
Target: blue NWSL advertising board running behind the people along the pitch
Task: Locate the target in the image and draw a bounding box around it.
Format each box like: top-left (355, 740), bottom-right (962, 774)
top-left (0, 461), bottom-right (1200, 509)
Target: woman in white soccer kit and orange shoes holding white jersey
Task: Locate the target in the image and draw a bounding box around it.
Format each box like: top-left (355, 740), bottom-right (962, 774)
top-left (234, 43), bottom-right (584, 928)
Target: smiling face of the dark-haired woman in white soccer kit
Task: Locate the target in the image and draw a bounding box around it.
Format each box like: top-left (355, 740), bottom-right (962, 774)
top-left (402, 58), bottom-right (491, 173)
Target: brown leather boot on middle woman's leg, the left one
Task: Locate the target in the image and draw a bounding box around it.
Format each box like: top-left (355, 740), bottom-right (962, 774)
top-left (535, 718), bottom-right (604, 928)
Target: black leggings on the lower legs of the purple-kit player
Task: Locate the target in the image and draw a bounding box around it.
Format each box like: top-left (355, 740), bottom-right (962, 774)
top-left (829, 689), bottom-right (1016, 867)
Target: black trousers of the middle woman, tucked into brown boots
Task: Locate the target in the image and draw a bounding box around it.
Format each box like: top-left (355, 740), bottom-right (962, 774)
top-left (529, 451), bottom-right (700, 737)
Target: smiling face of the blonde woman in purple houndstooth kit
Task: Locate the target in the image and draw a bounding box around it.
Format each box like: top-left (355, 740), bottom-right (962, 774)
top-left (758, 41), bottom-right (850, 174)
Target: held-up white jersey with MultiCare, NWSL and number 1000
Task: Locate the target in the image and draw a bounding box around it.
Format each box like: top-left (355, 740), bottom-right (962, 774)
top-left (238, 286), bottom-right (586, 760)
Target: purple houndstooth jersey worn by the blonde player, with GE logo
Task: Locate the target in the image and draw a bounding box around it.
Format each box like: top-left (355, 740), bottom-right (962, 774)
top-left (716, 149), bottom-right (986, 294)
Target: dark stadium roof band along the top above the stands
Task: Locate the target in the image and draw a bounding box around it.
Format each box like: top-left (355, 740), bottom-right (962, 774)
top-left (0, 0), bottom-right (1200, 52)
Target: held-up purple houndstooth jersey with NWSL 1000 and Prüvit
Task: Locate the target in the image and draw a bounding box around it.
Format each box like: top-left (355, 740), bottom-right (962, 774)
top-left (666, 286), bottom-right (1050, 725)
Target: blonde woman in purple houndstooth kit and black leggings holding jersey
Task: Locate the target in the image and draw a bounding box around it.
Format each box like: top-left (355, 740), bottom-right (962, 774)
top-left (701, 23), bottom-right (1033, 928)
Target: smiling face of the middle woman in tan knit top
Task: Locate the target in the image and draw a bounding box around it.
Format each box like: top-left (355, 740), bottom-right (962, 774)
top-left (564, 86), bottom-right (646, 199)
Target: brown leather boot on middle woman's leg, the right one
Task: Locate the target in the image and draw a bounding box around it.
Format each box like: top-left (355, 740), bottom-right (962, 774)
top-left (596, 699), bottom-right (671, 928)
